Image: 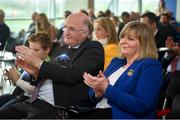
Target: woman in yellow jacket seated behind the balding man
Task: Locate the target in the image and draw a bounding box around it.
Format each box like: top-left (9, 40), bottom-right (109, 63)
top-left (94, 17), bottom-right (120, 69)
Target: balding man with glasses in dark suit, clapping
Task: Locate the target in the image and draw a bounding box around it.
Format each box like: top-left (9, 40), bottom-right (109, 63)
top-left (0, 13), bottom-right (104, 118)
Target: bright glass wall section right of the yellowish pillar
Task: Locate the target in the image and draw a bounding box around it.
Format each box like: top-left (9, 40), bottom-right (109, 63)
top-left (94, 0), bottom-right (158, 16)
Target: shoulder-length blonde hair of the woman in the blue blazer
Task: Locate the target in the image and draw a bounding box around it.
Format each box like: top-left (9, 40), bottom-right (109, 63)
top-left (120, 21), bottom-right (158, 59)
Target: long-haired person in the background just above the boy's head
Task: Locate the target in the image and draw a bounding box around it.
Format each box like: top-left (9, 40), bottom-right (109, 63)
top-left (37, 13), bottom-right (57, 42)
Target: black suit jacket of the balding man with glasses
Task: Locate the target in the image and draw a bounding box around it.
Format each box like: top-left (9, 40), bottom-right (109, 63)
top-left (38, 40), bottom-right (104, 107)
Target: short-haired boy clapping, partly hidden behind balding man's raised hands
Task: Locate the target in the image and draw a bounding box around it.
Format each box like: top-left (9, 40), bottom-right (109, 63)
top-left (0, 32), bottom-right (52, 109)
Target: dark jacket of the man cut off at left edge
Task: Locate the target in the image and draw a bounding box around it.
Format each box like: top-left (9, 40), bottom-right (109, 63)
top-left (0, 23), bottom-right (10, 50)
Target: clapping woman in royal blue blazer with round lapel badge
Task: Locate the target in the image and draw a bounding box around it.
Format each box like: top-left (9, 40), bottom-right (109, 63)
top-left (83, 21), bottom-right (163, 119)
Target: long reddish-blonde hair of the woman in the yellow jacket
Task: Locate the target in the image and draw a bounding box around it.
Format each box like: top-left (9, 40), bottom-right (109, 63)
top-left (94, 17), bottom-right (118, 44)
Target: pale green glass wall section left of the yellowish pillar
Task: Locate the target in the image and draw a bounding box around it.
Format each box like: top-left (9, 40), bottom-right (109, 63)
top-left (0, 0), bottom-right (88, 33)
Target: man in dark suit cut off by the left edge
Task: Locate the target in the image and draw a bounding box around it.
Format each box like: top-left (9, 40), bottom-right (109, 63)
top-left (0, 9), bottom-right (10, 50)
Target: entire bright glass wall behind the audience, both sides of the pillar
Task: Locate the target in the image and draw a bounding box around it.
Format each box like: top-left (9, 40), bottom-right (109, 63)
top-left (0, 0), bottom-right (158, 33)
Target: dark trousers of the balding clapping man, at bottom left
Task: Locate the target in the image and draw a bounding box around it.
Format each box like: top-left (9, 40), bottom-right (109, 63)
top-left (0, 99), bottom-right (55, 119)
